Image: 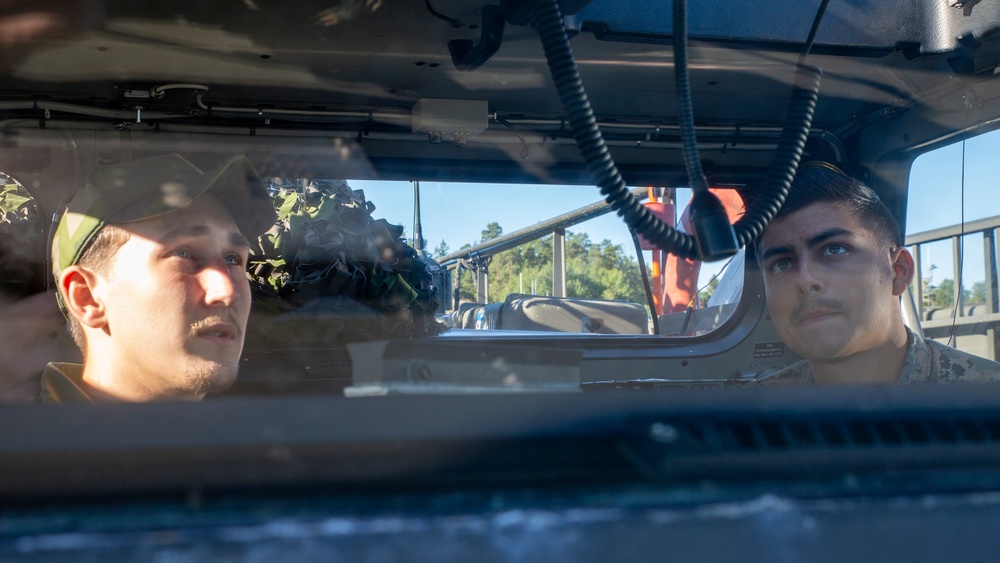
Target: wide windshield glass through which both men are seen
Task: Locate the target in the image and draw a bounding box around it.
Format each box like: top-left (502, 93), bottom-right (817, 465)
top-left (0, 1), bottom-right (1000, 412)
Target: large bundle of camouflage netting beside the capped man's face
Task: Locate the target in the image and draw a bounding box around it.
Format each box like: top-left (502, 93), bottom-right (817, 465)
top-left (247, 181), bottom-right (444, 348)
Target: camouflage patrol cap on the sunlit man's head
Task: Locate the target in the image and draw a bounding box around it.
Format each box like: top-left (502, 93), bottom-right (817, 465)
top-left (52, 154), bottom-right (275, 282)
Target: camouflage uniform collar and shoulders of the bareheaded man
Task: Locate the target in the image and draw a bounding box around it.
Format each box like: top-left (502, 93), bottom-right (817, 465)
top-left (761, 328), bottom-right (1000, 385)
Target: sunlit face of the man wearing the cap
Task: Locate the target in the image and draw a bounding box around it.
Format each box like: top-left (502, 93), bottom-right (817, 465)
top-left (94, 196), bottom-right (250, 398)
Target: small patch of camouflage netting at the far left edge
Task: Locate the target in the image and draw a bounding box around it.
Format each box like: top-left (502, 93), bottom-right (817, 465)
top-left (0, 172), bottom-right (45, 297)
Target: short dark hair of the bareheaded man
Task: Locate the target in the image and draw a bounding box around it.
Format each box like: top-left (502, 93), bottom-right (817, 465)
top-left (754, 162), bottom-right (904, 259)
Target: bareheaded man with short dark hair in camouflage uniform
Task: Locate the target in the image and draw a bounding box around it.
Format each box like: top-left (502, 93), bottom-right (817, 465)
top-left (755, 164), bottom-right (1000, 384)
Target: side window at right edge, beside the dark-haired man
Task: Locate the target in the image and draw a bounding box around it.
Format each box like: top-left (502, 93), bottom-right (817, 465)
top-left (906, 131), bottom-right (1000, 360)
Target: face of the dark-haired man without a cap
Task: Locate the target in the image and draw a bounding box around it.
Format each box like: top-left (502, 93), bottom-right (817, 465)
top-left (760, 203), bottom-right (909, 361)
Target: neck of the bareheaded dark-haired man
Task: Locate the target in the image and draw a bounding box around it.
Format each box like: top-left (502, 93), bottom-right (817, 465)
top-left (809, 325), bottom-right (909, 385)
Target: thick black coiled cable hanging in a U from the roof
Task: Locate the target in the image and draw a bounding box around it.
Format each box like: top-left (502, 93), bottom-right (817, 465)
top-left (532, 0), bottom-right (822, 259)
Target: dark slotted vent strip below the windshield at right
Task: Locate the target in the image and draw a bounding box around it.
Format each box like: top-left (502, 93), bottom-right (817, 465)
top-left (627, 414), bottom-right (1000, 477)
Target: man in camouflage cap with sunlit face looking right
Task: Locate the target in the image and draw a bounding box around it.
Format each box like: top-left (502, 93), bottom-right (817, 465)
top-left (40, 154), bottom-right (275, 403)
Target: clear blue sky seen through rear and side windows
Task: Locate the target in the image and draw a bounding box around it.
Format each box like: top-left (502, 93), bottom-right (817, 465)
top-left (350, 131), bottom-right (1000, 298)
